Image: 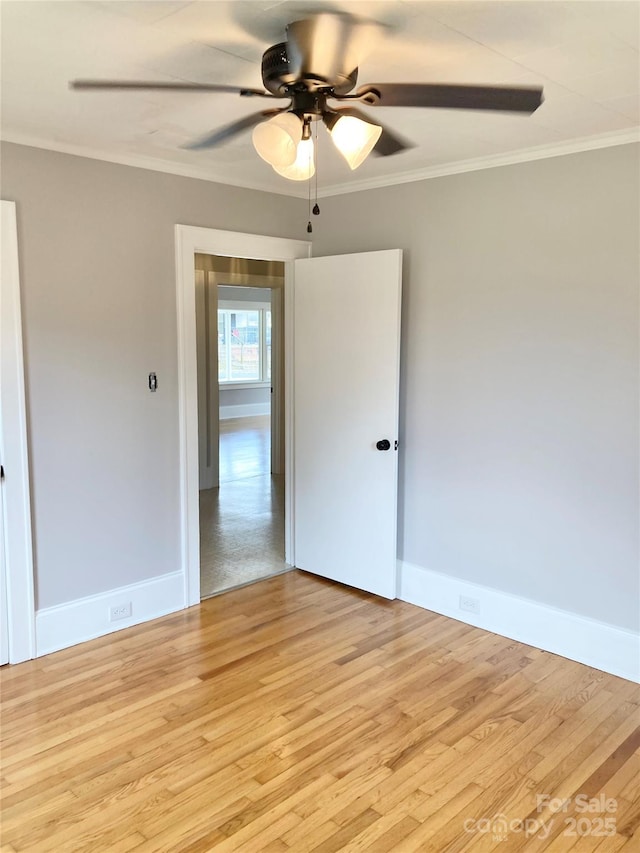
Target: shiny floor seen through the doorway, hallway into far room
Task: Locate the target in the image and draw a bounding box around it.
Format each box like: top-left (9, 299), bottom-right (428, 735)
top-left (200, 416), bottom-right (288, 598)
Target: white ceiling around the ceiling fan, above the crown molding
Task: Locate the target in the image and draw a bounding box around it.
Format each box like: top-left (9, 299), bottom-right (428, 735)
top-left (0, 0), bottom-right (640, 195)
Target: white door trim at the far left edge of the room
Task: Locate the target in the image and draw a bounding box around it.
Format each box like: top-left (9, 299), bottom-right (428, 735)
top-left (0, 201), bottom-right (36, 663)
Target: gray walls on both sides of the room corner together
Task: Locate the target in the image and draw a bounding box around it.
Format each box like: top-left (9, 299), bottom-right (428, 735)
top-left (2, 138), bottom-right (639, 627)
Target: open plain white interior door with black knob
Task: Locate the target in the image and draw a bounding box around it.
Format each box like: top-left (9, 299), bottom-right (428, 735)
top-left (293, 249), bottom-right (402, 598)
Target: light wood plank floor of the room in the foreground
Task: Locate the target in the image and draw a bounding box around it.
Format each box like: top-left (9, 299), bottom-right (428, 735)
top-left (0, 571), bottom-right (640, 853)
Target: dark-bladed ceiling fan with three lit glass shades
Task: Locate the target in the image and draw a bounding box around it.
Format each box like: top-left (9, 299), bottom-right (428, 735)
top-left (70, 12), bottom-right (543, 180)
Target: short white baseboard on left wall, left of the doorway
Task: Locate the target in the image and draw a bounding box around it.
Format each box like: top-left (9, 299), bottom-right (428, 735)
top-left (36, 572), bottom-right (184, 657)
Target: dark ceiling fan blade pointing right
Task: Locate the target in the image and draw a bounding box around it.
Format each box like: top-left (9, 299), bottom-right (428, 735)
top-left (355, 83), bottom-right (543, 113)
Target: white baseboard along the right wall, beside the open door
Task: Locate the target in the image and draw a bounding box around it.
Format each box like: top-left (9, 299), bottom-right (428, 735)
top-left (398, 560), bottom-right (640, 683)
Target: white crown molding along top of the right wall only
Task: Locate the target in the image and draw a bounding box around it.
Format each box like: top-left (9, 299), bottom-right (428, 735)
top-left (318, 127), bottom-right (640, 198)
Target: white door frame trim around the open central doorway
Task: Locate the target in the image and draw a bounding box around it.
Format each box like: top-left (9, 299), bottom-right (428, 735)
top-left (175, 225), bottom-right (311, 607)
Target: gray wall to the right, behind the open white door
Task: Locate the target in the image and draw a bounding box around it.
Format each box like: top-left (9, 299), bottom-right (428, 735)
top-left (314, 146), bottom-right (640, 627)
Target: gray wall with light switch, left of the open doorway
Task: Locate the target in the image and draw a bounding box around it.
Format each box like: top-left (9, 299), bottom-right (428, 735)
top-left (2, 144), bottom-right (306, 608)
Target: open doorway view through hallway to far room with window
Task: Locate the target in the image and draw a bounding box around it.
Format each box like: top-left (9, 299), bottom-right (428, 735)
top-left (194, 253), bottom-right (289, 598)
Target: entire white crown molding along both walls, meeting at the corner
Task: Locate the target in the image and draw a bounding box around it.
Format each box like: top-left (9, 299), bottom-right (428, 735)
top-left (0, 127), bottom-right (640, 198)
